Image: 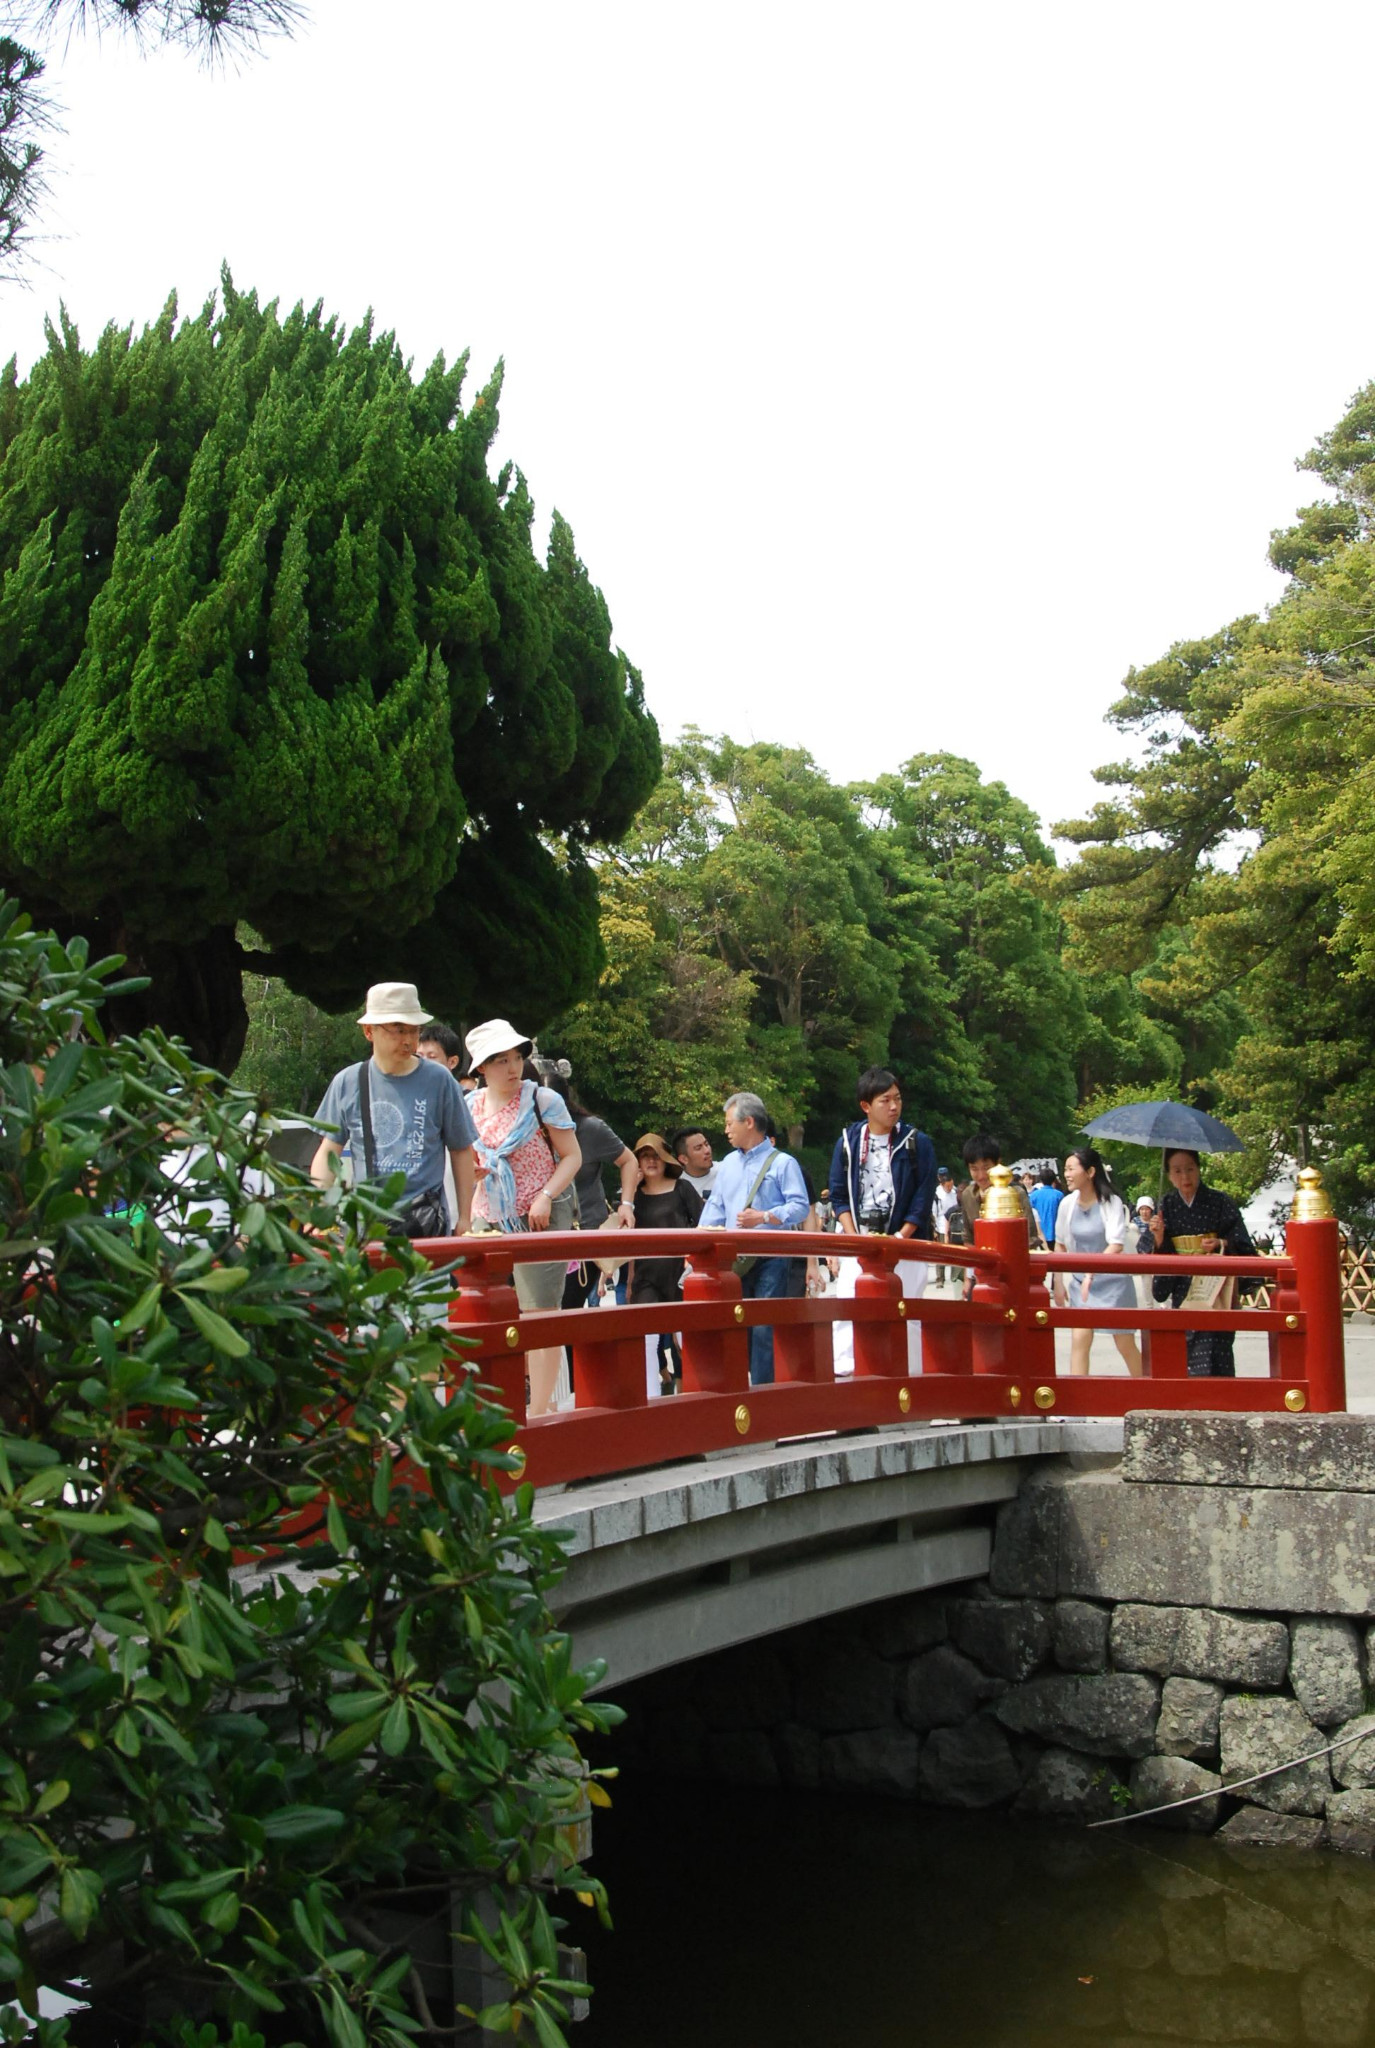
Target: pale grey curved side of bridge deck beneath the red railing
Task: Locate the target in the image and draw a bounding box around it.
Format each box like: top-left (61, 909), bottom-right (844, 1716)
top-left (535, 1419), bottom-right (1123, 1686)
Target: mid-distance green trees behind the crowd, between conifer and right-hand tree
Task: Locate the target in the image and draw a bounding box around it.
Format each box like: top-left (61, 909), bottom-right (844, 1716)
top-left (545, 731), bottom-right (1182, 1155)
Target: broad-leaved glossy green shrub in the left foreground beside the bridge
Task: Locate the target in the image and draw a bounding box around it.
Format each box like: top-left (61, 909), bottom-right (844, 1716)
top-left (0, 903), bottom-right (617, 2048)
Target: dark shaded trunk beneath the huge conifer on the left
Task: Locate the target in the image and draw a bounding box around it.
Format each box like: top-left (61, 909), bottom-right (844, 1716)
top-left (82, 913), bottom-right (248, 1073)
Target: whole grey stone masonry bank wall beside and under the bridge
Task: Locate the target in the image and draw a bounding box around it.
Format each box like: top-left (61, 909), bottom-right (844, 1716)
top-left (619, 1415), bottom-right (1375, 1855)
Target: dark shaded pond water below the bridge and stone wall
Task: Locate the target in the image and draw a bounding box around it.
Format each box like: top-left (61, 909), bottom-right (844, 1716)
top-left (574, 1778), bottom-right (1375, 2048)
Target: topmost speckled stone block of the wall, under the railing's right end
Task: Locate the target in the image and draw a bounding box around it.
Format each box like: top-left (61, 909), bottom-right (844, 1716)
top-left (1121, 1409), bottom-right (1375, 1493)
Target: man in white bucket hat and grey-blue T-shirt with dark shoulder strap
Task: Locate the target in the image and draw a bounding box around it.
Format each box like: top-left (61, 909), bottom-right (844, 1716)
top-left (309, 981), bottom-right (477, 1237)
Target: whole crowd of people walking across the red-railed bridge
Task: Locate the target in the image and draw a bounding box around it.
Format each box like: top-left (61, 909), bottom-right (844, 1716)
top-left (311, 983), bottom-right (1252, 1415)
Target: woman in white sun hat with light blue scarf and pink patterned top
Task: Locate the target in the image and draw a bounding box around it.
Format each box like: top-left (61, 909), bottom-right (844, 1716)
top-left (463, 1018), bottom-right (582, 1415)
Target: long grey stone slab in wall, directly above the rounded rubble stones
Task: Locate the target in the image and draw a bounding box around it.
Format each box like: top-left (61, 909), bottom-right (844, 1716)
top-left (1004, 1473), bottom-right (1375, 1618)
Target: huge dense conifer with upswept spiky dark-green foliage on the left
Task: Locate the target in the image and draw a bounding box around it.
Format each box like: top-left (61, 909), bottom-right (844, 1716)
top-left (0, 274), bottom-right (658, 1071)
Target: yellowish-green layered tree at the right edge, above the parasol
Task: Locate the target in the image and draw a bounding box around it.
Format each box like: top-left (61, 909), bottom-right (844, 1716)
top-left (1059, 385), bottom-right (1375, 1214)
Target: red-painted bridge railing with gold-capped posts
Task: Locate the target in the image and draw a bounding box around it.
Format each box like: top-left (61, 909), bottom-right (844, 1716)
top-left (405, 1217), bottom-right (1346, 1485)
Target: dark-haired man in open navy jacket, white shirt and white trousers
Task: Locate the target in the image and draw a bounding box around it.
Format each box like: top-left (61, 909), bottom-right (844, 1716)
top-left (830, 1067), bottom-right (936, 1372)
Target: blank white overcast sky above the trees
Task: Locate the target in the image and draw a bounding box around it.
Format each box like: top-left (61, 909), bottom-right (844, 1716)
top-left (10, 0), bottom-right (1375, 839)
